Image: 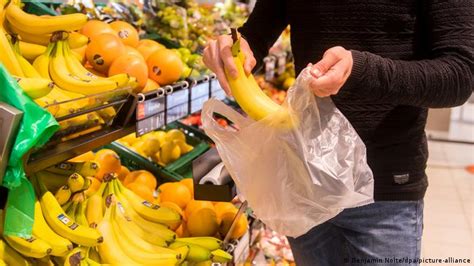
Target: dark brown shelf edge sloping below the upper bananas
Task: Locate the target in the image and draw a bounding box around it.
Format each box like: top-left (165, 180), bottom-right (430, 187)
top-left (25, 125), bottom-right (135, 174)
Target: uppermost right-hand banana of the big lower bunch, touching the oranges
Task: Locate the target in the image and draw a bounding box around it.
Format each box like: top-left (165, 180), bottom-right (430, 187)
top-left (111, 179), bottom-right (181, 228)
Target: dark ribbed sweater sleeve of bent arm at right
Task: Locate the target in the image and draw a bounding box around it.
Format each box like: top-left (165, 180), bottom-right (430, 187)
top-left (338, 0), bottom-right (474, 108)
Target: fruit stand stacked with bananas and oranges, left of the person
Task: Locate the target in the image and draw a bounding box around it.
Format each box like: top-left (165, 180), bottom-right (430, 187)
top-left (0, 0), bottom-right (296, 265)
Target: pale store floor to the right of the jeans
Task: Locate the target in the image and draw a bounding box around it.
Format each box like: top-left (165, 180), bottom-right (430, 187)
top-left (422, 140), bottom-right (474, 265)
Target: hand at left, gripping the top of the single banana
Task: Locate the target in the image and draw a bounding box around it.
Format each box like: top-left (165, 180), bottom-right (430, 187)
top-left (203, 35), bottom-right (257, 95)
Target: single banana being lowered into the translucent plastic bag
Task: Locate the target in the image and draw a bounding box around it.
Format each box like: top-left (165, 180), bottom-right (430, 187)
top-left (225, 32), bottom-right (297, 128)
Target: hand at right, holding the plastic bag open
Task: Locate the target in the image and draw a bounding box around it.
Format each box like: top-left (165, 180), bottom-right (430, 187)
top-left (310, 46), bottom-right (353, 97)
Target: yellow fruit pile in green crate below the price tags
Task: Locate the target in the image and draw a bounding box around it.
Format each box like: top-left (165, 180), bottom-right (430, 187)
top-left (118, 129), bottom-right (193, 166)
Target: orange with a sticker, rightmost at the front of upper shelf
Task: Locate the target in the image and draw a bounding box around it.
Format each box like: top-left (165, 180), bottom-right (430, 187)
top-left (146, 49), bottom-right (184, 85)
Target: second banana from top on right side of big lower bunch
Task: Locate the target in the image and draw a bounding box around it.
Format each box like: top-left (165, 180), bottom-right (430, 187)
top-left (111, 181), bottom-right (176, 246)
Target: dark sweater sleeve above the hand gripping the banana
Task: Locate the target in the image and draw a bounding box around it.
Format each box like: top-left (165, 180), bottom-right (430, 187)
top-left (239, 0), bottom-right (288, 67)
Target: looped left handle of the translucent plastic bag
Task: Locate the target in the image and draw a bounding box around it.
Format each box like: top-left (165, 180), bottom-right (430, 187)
top-left (201, 99), bottom-right (249, 137)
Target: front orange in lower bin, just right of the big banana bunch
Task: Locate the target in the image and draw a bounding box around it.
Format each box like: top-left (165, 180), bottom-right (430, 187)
top-left (186, 208), bottom-right (219, 236)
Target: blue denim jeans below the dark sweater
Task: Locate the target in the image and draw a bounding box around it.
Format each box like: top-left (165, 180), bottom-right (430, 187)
top-left (288, 200), bottom-right (423, 266)
